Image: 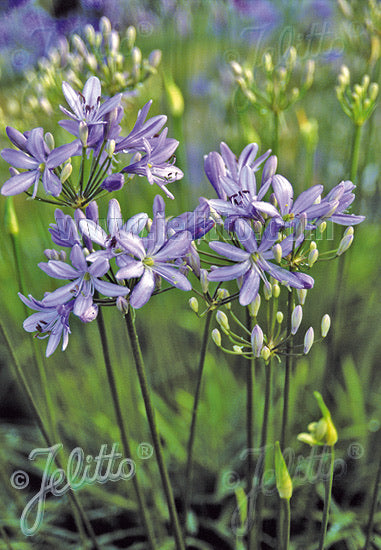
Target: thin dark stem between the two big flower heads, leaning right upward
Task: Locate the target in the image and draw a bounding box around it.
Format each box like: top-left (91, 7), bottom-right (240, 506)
top-left (183, 310), bottom-right (213, 529)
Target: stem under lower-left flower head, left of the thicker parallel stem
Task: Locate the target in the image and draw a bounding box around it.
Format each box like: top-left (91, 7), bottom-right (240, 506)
top-left (97, 308), bottom-right (157, 550)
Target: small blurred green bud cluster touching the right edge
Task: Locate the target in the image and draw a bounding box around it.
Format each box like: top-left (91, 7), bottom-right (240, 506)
top-left (336, 65), bottom-right (378, 126)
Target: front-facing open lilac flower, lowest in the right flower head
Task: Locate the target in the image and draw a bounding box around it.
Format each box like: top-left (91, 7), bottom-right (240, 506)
top-left (208, 218), bottom-right (314, 306)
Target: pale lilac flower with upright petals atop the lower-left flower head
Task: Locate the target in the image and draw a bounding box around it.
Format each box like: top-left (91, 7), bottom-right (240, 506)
top-left (79, 199), bottom-right (148, 261)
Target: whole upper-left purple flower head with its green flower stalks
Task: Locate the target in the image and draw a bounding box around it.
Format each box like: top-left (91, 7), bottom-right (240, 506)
top-left (1, 76), bottom-right (183, 201)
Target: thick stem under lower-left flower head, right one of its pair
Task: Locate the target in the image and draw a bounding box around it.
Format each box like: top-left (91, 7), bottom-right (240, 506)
top-left (125, 308), bottom-right (185, 550)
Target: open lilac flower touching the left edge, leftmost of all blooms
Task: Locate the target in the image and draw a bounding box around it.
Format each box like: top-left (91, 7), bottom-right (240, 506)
top-left (1, 127), bottom-right (78, 198)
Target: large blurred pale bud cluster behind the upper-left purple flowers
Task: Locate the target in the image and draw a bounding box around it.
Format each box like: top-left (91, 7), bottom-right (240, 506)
top-left (26, 17), bottom-right (161, 118)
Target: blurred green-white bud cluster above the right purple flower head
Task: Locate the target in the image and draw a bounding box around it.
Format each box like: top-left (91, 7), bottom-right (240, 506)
top-left (231, 46), bottom-right (315, 113)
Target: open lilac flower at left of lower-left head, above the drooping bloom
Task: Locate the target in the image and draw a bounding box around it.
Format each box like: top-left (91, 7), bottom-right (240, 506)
top-left (38, 244), bottom-right (129, 317)
